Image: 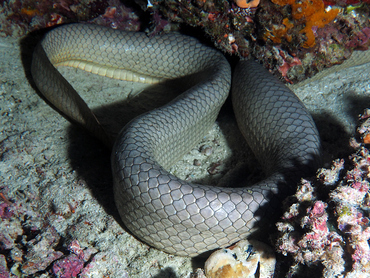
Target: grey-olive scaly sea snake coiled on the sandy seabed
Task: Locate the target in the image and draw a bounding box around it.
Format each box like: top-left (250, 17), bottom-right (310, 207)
top-left (31, 24), bottom-right (320, 256)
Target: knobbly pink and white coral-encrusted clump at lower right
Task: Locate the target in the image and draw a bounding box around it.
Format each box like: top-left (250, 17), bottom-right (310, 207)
top-left (276, 109), bottom-right (370, 277)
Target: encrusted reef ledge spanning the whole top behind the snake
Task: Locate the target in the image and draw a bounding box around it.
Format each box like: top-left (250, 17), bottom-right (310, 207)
top-left (0, 0), bottom-right (370, 83)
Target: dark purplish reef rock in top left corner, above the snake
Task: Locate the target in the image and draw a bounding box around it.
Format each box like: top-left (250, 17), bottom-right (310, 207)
top-left (0, 0), bottom-right (140, 36)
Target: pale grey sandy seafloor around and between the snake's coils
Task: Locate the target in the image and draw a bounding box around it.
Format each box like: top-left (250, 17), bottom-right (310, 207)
top-left (0, 31), bottom-right (370, 278)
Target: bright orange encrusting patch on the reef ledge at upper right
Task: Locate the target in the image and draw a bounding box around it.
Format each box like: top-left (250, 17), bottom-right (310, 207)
top-left (271, 0), bottom-right (339, 48)
